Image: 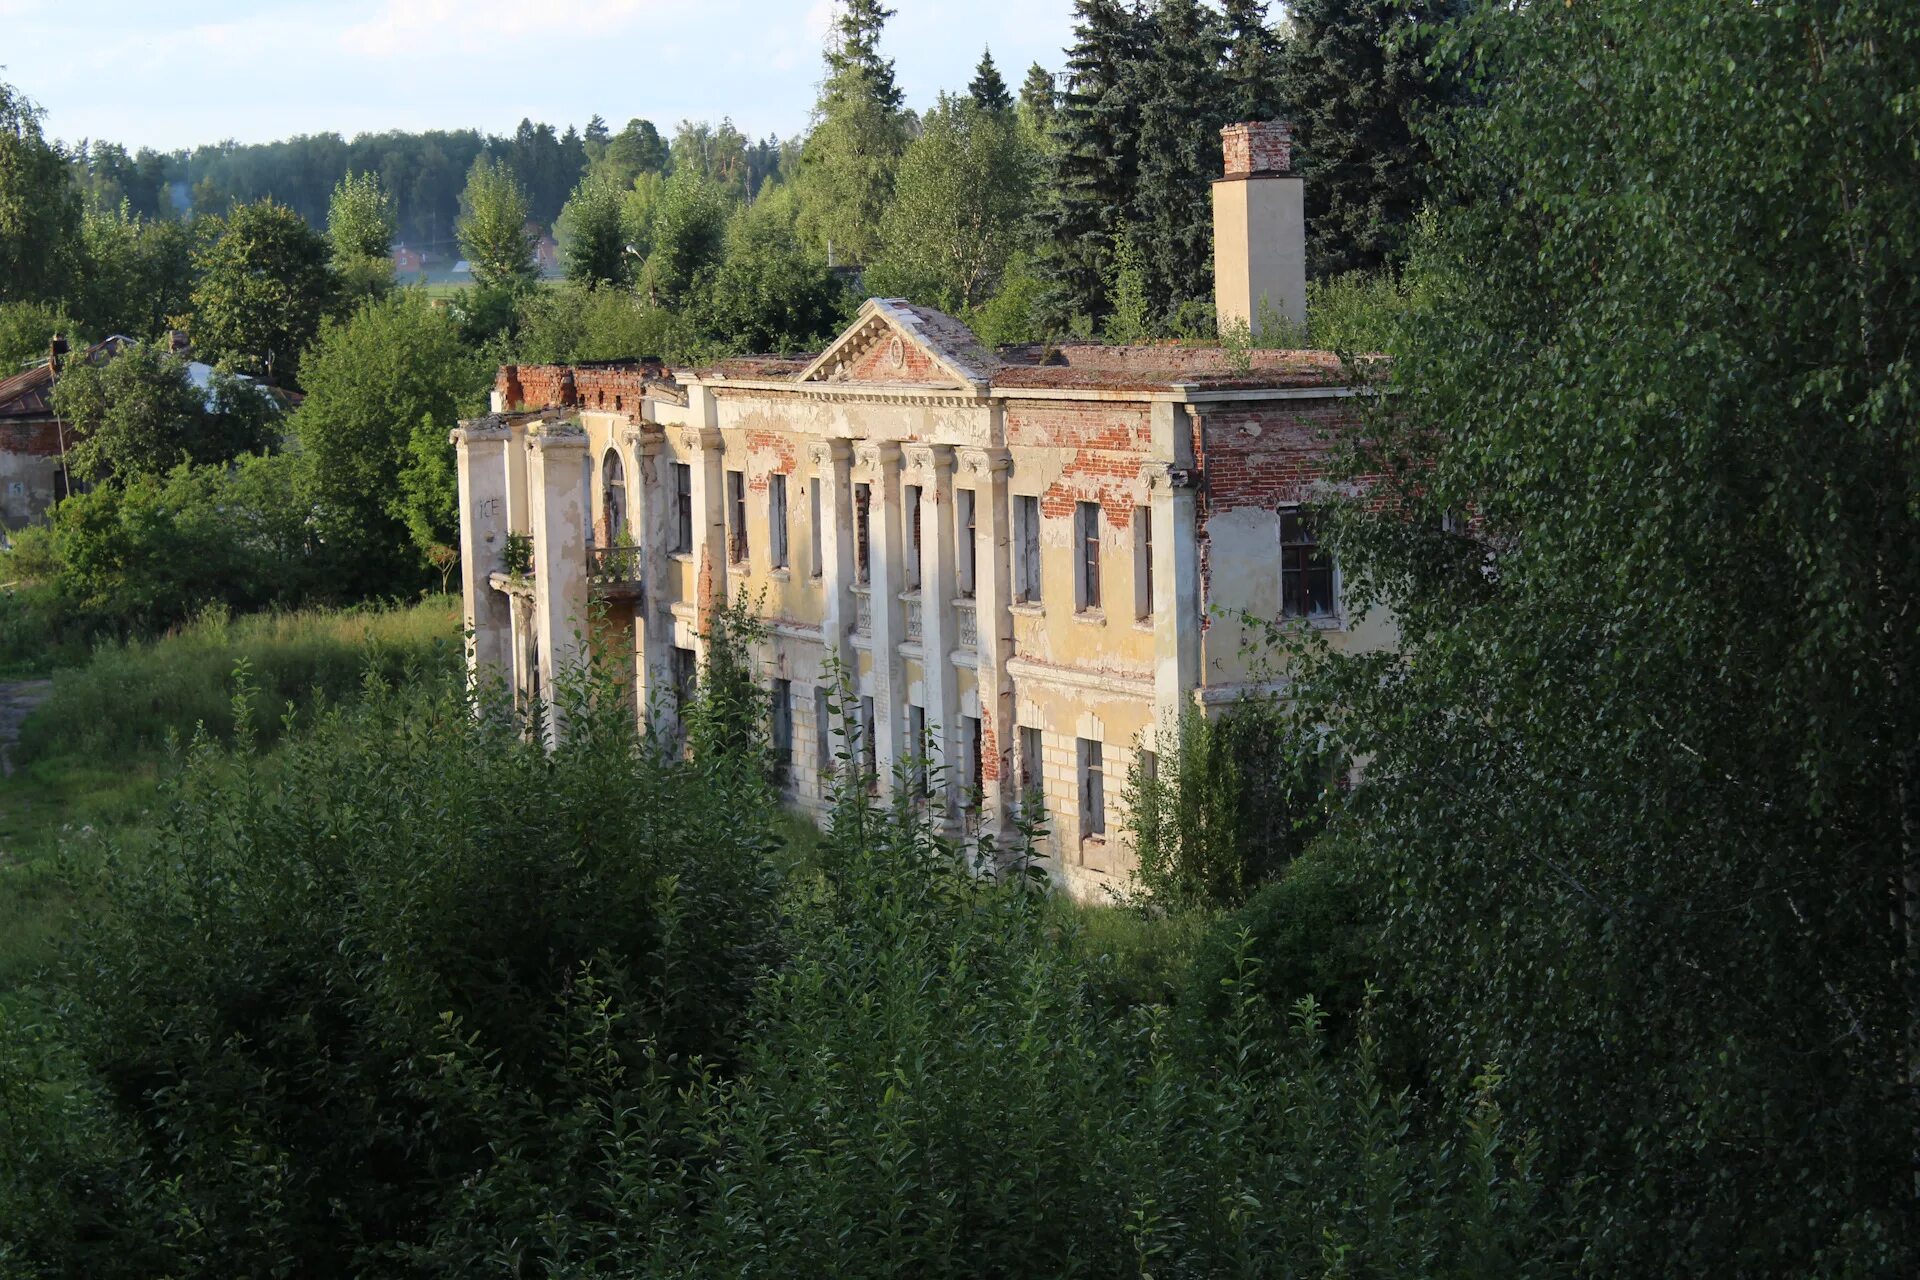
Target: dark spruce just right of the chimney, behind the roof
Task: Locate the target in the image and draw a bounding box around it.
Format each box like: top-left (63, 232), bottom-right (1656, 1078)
top-left (1281, 0), bottom-right (1465, 278)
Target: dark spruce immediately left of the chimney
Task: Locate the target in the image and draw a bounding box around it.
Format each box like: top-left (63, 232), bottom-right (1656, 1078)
top-left (1127, 0), bottom-right (1225, 322)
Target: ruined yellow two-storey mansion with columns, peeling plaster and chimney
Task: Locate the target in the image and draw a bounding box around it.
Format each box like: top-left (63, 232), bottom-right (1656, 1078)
top-left (464, 125), bottom-right (1392, 894)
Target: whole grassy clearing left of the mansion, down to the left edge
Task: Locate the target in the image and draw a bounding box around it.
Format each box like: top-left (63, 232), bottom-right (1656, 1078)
top-left (0, 597), bottom-right (459, 992)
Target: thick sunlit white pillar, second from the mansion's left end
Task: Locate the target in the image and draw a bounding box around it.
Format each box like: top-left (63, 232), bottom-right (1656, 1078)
top-left (528, 422), bottom-right (589, 745)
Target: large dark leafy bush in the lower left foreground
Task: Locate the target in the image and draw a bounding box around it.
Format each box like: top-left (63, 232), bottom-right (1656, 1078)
top-left (0, 667), bottom-right (778, 1276)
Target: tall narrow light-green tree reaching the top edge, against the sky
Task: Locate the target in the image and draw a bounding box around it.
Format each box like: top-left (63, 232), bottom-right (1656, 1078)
top-left (795, 0), bottom-right (906, 263)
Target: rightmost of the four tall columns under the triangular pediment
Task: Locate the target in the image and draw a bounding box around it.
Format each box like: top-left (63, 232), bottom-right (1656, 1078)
top-left (960, 449), bottom-right (1020, 842)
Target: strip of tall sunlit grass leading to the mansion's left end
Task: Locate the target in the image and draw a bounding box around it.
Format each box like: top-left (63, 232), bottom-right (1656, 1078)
top-left (15, 597), bottom-right (461, 766)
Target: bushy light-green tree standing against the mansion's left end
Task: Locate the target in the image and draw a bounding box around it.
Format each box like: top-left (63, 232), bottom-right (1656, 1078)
top-left (292, 292), bottom-right (488, 593)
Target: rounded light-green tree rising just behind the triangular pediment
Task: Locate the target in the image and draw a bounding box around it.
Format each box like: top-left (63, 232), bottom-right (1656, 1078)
top-left (870, 96), bottom-right (1039, 313)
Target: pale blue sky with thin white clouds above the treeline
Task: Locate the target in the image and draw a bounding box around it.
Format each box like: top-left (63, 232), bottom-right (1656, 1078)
top-left (0, 0), bottom-right (1073, 150)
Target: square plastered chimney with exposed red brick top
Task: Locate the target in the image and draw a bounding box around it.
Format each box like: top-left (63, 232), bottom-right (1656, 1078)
top-left (1213, 121), bottom-right (1308, 334)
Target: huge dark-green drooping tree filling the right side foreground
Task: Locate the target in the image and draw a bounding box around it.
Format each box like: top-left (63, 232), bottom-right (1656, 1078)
top-left (1296, 0), bottom-right (1920, 1276)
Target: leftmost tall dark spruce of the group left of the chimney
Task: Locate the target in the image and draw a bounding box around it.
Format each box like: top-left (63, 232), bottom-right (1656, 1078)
top-left (1037, 0), bottom-right (1152, 326)
